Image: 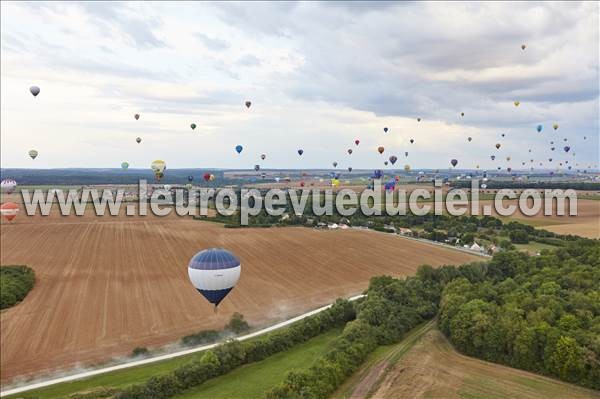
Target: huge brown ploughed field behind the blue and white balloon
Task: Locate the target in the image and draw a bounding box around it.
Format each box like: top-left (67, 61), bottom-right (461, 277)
top-left (0, 212), bottom-right (480, 383)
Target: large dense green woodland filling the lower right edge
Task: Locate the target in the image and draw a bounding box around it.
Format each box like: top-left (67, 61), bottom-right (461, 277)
top-left (439, 244), bottom-right (600, 389)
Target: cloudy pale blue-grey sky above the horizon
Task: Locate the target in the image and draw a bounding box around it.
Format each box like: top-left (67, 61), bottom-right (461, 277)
top-left (0, 2), bottom-right (600, 169)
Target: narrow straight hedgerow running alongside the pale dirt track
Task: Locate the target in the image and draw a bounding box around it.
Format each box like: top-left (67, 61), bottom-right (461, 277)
top-left (115, 300), bottom-right (356, 399)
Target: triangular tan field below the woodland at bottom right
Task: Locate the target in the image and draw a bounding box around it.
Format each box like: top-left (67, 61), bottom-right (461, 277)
top-left (366, 328), bottom-right (600, 399)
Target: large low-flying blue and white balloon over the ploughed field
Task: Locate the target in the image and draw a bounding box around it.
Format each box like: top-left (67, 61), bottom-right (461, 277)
top-left (188, 248), bottom-right (242, 311)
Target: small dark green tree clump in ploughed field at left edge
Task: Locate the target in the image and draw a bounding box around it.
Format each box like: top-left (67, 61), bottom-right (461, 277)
top-left (0, 266), bottom-right (35, 309)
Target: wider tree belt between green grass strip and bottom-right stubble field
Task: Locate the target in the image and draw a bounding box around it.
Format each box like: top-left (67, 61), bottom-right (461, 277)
top-left (266, 266), bottom-right (450, 399)
